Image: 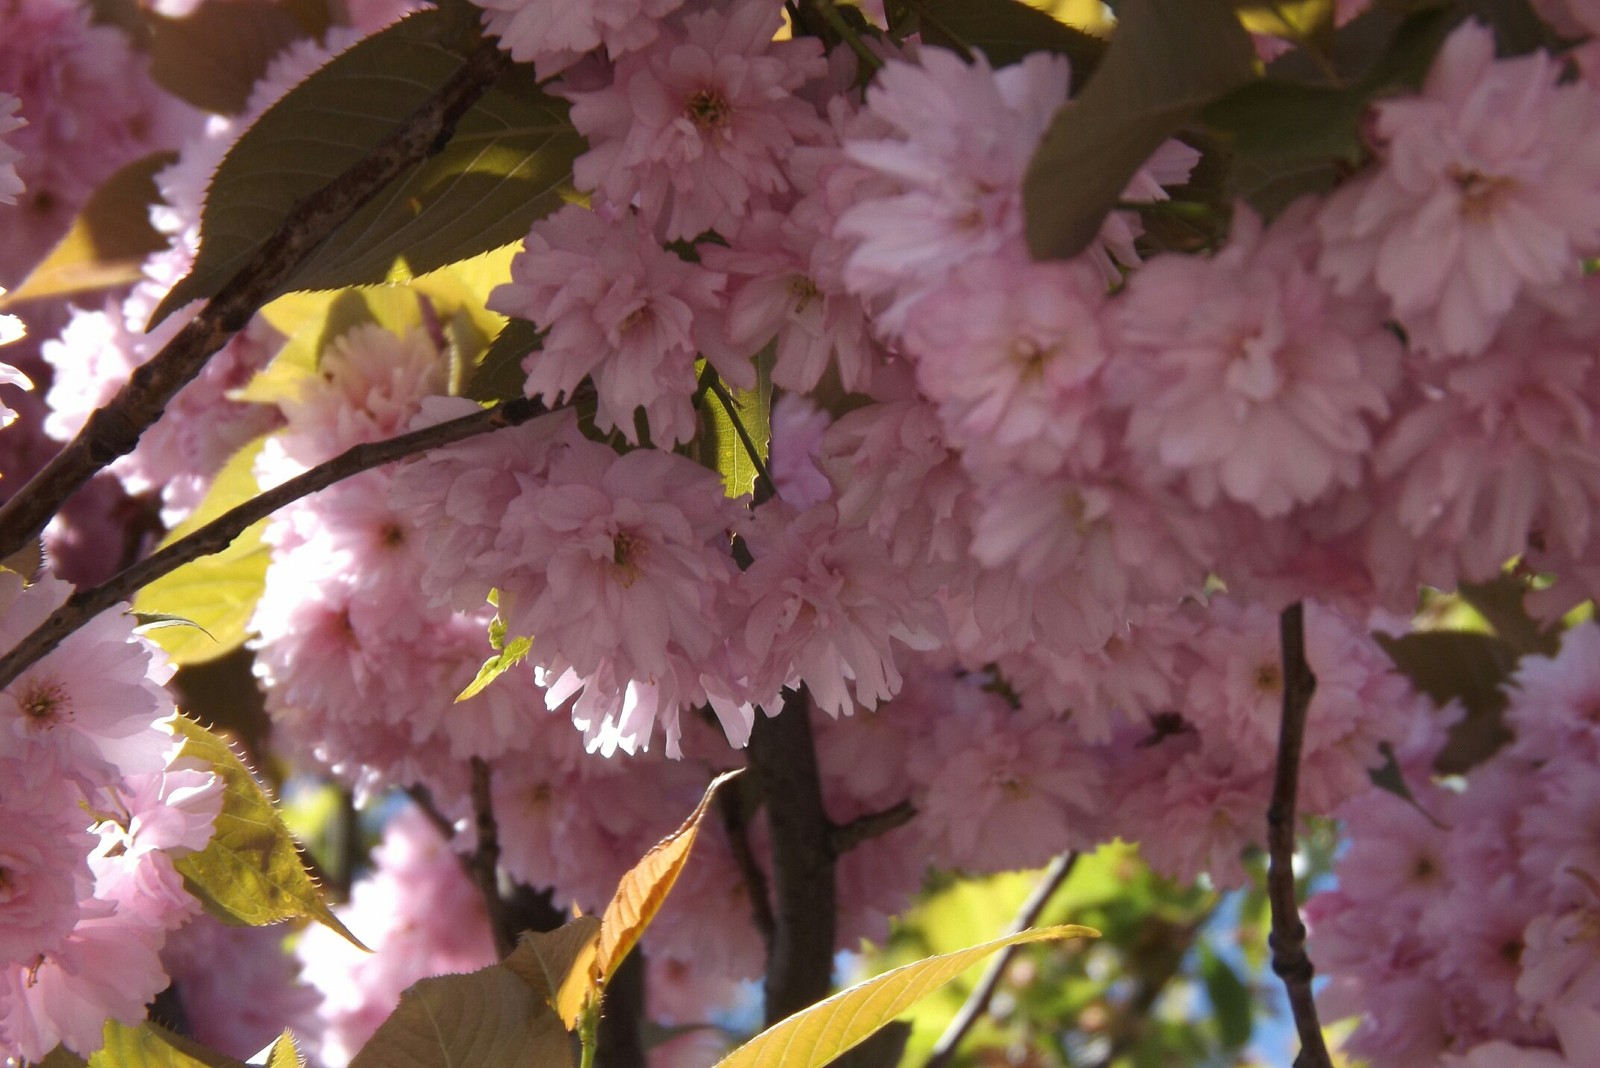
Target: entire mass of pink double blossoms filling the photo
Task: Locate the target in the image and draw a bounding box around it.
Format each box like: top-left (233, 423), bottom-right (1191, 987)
top-left (9, 0), bottom-right (1600, 1068)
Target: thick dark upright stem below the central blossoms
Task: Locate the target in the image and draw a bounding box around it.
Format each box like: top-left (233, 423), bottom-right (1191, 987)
top-left (747, 689), bottom-right (838, 1025)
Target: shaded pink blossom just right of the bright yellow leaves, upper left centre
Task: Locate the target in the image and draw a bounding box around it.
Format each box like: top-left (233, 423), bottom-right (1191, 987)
top-left (490, 205), bottom-right (739, 444)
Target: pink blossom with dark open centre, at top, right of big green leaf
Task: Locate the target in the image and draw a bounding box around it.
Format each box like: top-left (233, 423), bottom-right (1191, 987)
top-left (566, 3), bottom-right (827, 241)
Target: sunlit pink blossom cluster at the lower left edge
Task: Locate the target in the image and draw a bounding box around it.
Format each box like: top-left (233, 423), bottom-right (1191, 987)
top-left (0, 571), bottom-right (222, 1063)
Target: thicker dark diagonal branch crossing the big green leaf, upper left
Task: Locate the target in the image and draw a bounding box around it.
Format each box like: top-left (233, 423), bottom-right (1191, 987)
top-left (0, 42), bottom-right (509, 560)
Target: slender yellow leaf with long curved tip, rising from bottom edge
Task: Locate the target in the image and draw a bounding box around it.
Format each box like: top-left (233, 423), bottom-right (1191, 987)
top-left (717, 924), bottom-right (1099, 1068)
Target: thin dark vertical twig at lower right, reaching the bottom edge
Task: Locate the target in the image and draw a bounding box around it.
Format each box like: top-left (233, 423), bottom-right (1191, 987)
top-left (1267, 601), bottom-right (1333, 1068)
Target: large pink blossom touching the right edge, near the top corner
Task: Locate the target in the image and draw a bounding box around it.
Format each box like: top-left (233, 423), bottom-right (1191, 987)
top-left (1318, 22), bottom-right (1600, 355)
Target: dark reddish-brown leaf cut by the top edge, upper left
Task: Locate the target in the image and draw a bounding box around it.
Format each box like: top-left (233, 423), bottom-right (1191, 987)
top-left (146, 0), bottom-right (330, 115)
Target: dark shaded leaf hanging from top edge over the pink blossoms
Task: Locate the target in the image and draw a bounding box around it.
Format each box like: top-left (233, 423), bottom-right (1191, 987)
top-left (1022, 0), bottom-right (1256, 259)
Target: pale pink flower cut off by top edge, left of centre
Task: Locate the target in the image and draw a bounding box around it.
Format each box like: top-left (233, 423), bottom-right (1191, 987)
top-left (477, 0), bottom-right (683, 82)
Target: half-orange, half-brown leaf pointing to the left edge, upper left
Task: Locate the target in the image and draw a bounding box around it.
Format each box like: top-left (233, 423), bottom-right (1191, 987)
top-left (0, 152), bottom-right (178, 309)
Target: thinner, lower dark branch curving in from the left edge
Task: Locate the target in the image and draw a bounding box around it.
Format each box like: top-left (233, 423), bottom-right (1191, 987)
top-left (0, 398), bottom-right (549, 687)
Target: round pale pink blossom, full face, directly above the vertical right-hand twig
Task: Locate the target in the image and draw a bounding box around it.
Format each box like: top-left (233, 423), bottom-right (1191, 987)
top-left (1109, 200), bottom-right (1402, 518)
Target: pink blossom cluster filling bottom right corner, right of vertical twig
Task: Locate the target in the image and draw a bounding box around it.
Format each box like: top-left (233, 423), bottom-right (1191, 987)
top-left (1307, 622), bottom-right (1600, 1068)
